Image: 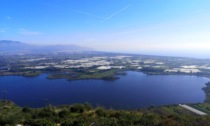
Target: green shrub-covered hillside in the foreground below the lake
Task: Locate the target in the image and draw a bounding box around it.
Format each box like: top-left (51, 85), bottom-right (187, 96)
top-left (0, 101), bottom-right (210, 126)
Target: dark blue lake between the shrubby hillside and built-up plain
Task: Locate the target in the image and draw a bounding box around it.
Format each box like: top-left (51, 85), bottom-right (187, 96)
top-left (0, 71), bottom-right (210, 109)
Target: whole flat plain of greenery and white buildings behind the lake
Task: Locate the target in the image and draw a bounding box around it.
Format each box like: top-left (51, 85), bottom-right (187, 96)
top-left (0, 53), bottom-right (210, 80)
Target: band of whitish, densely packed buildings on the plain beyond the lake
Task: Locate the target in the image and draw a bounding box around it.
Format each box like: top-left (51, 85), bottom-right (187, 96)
top-left (16, 55), bottom-right (210, 73)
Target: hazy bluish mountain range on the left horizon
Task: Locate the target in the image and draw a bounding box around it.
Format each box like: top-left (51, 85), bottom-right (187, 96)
top-left (0, 40), bottom-right (93, 54)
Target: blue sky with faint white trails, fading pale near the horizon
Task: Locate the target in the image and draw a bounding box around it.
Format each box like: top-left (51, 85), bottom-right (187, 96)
top-left (0, 0), bottom-right (210, 58)
